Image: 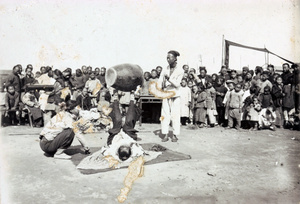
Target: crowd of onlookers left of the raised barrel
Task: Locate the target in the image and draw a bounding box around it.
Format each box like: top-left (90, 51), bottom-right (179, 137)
top-left (1, 64), bottom-right (109, 127)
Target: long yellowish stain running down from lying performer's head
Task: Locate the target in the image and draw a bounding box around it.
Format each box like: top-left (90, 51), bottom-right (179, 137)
top-left (118, 156), bottom-right (145, 203)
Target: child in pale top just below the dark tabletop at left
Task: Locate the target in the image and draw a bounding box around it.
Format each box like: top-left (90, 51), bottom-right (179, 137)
top-left (22, 90), bottom-right (43, 127)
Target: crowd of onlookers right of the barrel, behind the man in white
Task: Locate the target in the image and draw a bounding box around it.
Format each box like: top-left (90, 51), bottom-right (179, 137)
top-left (143, 63), bottom-right (300, 130)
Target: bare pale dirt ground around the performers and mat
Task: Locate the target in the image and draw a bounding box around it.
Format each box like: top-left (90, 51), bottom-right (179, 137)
top-left (0, 124), bottom-right (300, 204)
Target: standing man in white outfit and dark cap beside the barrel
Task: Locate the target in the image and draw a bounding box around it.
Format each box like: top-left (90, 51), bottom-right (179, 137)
top-left (157, 50), bottom-right (183, 142)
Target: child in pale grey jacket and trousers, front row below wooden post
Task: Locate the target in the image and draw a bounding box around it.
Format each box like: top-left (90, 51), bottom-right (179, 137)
top-left (228, 84), bottom-right (243, 130)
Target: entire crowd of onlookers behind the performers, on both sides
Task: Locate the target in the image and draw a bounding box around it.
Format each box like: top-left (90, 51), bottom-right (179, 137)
top-left (1, 63), bottom-right (300, 130)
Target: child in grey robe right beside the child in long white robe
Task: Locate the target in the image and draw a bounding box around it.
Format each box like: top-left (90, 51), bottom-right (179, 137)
top-left (193, 86), bottom-right (207, 128)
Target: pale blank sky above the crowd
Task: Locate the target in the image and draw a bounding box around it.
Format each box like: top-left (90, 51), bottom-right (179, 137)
top-left (0, 0), bottom-right (300, 73)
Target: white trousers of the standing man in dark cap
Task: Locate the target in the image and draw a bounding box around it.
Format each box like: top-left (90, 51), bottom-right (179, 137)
top-left (161, 97), bottom-right (180, 136)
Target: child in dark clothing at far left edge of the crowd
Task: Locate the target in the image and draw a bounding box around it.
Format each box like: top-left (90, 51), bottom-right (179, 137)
top-left (5, 85), bottom-right (20, 125)
